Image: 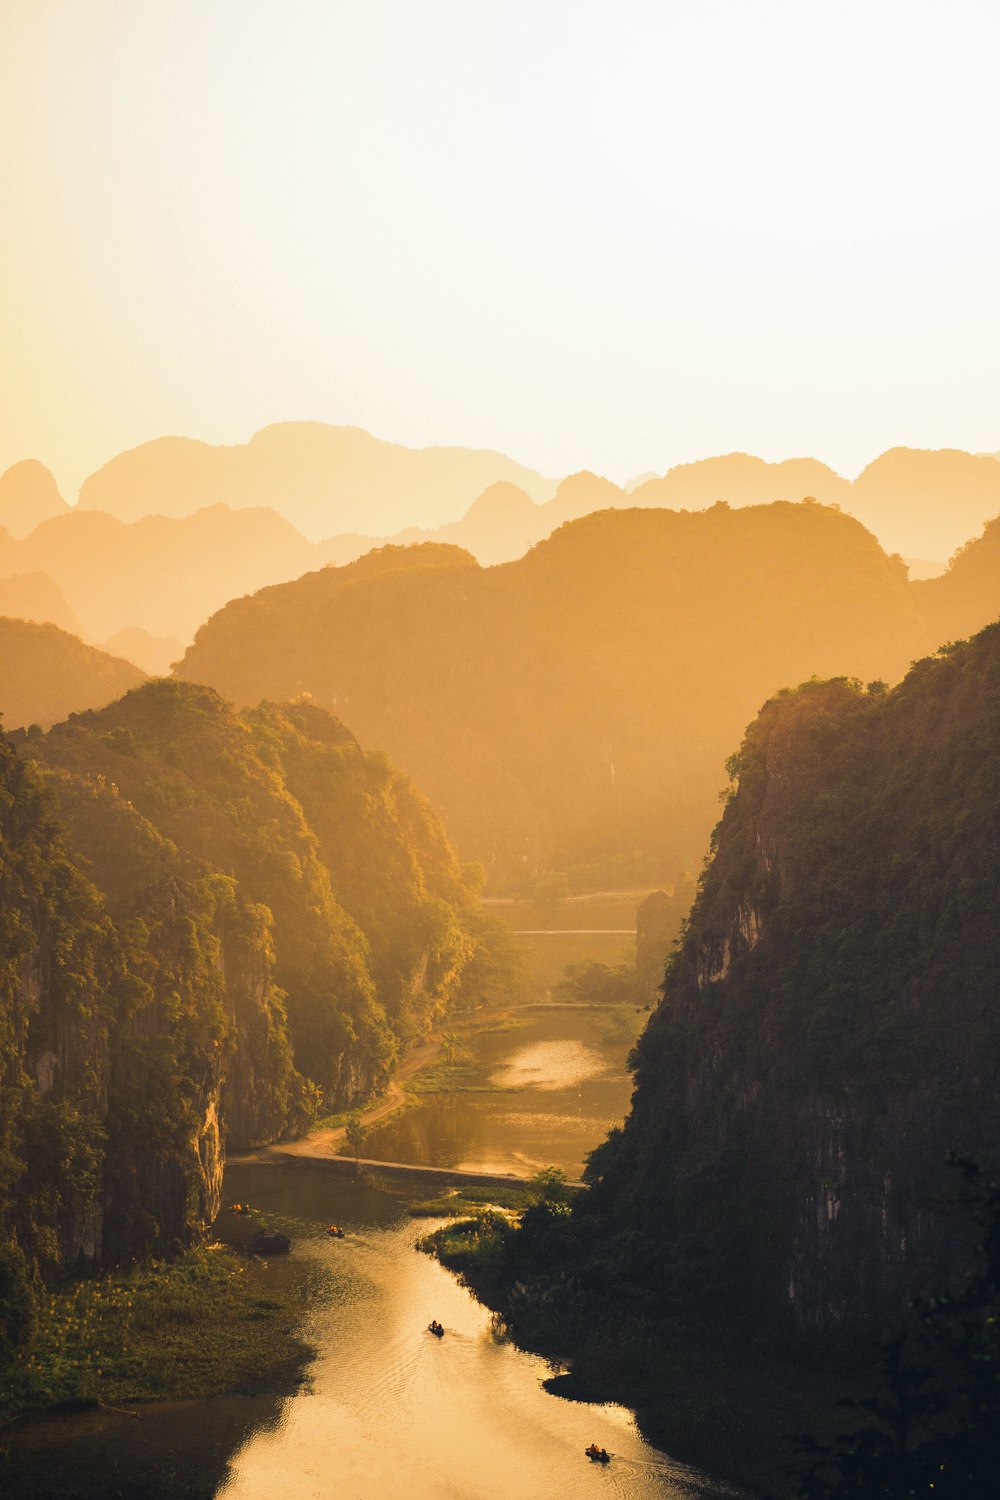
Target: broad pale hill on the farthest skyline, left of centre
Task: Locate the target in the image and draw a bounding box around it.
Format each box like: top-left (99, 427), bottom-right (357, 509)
top-left (79, 422), bottom-right (563, 540)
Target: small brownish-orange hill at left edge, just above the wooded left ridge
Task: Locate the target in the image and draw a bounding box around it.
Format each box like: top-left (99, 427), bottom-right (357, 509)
top-left (0, 618), bottom-right (144, 729)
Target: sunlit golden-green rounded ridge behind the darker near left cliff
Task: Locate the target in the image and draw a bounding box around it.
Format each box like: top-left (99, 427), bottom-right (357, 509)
top-left (27, 681), bottom-right (500, 1104)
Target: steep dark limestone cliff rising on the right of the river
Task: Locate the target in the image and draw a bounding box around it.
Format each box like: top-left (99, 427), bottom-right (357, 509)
top-left (595, 627), bottom-right (1000, 1337)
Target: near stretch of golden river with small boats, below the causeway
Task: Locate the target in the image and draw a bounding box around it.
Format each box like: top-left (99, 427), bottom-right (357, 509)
top-left (217, 1163), bottom-right (743, 1500)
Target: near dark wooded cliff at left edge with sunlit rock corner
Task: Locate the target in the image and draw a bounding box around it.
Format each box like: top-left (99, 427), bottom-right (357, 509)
top-left (0, 735), bottom-right (254, 1290)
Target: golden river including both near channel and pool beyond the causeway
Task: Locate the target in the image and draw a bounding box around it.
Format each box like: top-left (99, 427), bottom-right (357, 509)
top-left (209, 1010), bottom-right (736, 1500)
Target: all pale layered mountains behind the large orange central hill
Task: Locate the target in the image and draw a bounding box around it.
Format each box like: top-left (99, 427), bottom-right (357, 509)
top-left (0, 423), bottom-right (1000, 660)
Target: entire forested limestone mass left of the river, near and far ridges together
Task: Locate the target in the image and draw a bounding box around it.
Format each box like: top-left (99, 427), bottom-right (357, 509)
top-left (0, 681), bottom-right (513, 1392)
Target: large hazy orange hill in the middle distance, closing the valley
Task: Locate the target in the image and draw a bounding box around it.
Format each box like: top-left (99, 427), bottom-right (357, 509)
top-left (178, 503), bottom-right (1000, 882)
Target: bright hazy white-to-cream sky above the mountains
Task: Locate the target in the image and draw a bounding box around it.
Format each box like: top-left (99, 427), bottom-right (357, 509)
top-left (0, 0), bottom-right (1000, 498)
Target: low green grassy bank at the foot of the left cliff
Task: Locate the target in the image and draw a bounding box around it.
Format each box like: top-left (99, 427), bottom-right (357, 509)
top-left (0, 1245), bottom-right (309, 1418)
